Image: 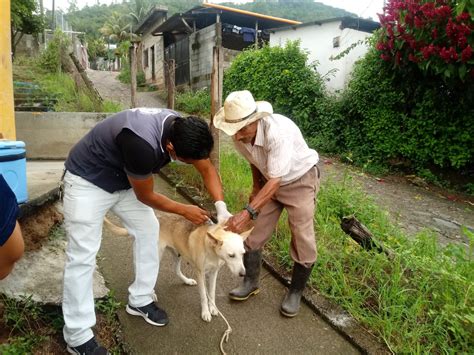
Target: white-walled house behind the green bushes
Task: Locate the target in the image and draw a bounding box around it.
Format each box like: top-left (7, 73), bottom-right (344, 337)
top-left (270, 17), bottom-right (380, 92)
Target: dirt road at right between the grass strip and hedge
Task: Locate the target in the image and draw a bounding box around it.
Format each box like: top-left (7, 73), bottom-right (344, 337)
top-left (320, 157), bottom-right (474, 245)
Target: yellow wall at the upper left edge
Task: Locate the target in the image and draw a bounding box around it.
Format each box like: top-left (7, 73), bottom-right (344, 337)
top-left (0, 0), bottom-right (16, 140)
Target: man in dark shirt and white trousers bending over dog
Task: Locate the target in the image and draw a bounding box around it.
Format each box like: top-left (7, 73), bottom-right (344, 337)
top-left (63, 108), bottom-right (230, 354)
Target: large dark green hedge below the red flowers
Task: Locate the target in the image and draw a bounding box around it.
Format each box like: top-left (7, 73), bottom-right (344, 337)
top-left (340, 50), bottom-right (474, 170)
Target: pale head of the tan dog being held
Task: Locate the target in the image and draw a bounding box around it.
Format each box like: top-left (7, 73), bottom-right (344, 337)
top-left (207, 225), bottom-right (252, 276)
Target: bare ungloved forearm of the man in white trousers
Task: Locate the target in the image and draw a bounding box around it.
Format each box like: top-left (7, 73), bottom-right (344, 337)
top-left (128, 176), bottom-right (209, 224)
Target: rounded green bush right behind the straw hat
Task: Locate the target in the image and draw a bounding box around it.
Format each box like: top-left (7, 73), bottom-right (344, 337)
top-left (224, 42), bottom-right (325, 131)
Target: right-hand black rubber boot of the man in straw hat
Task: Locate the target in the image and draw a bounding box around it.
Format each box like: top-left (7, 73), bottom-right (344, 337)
top-left (280, 263), bottom-right (313, 317)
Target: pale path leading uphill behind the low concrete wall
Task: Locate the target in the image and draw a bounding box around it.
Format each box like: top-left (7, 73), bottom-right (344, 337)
top-left (87, 69), bottom-right (166, 109)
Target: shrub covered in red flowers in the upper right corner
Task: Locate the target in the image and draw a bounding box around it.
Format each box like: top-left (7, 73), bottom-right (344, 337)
top-left (376, 0), bottom-right (474, 81)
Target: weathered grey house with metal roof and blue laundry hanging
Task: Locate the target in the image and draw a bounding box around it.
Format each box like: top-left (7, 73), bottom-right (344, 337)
top-left (135, 3), bottom-right (301, 89)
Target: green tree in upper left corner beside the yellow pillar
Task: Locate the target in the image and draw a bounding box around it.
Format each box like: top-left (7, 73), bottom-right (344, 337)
top-left (11, 0), bottom-right (44, 56)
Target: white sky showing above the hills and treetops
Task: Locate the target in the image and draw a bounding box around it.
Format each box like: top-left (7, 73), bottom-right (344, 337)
top-left (43, 0), bottom-right (384, 21)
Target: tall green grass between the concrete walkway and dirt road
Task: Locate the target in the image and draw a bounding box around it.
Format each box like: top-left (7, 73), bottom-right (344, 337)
top-left (166, 151), bottom-right (474, 353)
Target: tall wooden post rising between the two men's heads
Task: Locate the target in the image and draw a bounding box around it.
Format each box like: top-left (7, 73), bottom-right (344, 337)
top-left (211, 22), bottom-right (224, 173)
